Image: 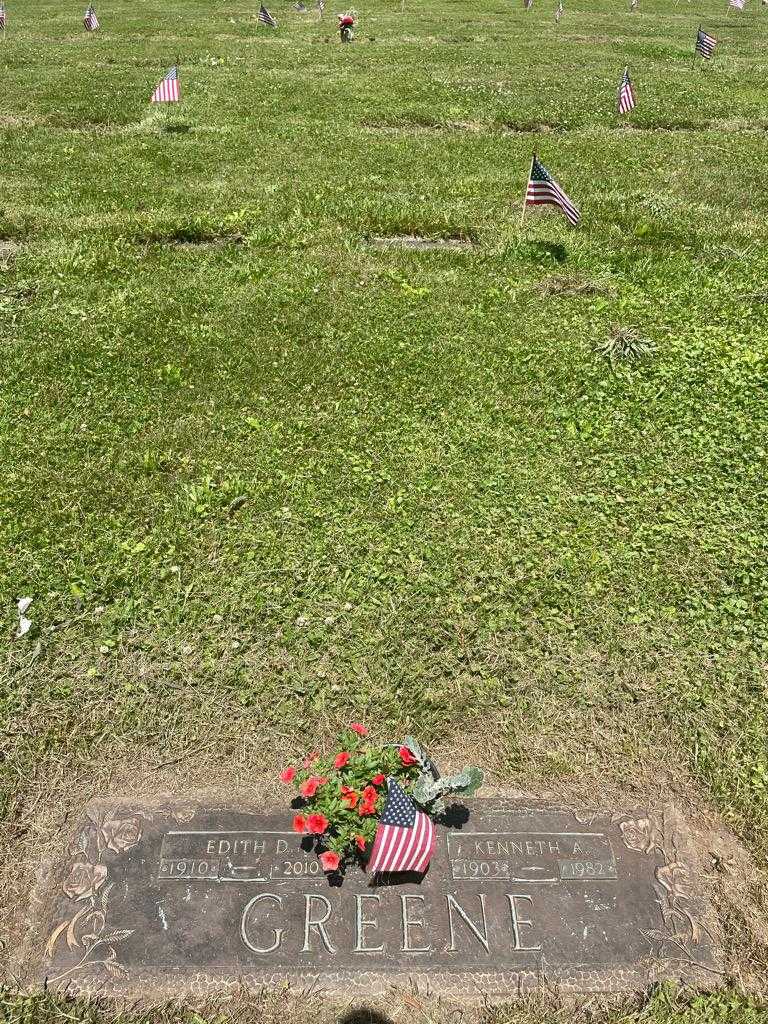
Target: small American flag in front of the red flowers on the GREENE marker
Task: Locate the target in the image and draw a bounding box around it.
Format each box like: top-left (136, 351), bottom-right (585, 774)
top-left (368, 778), bottom-right (436, 872)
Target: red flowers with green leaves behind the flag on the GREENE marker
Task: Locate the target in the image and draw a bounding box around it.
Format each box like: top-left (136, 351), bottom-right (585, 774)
top-left (280, 722), bottom-right (482, 872)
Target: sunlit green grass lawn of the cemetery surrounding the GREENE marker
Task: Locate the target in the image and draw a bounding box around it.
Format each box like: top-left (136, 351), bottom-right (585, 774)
top-left (0, 0), bottom-right (768, 1024)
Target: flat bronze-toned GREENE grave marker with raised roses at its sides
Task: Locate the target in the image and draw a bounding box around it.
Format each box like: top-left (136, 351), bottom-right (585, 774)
top-left (24, 798), bottom-right (722, 998)
